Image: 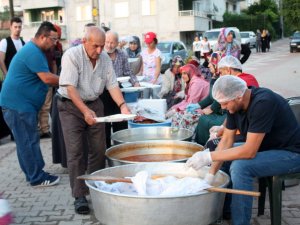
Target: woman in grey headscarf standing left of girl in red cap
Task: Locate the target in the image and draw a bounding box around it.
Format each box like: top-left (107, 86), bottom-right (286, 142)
top-left (126, 36), bottom-right (143, 76)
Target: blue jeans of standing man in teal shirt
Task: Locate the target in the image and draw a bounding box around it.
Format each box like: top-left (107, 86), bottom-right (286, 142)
top-left (2, 109), bottom-right (47, 184)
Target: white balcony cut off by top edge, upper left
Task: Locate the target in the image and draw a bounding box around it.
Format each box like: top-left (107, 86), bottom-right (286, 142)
top-left (21, 0), bottom-right (65, 10)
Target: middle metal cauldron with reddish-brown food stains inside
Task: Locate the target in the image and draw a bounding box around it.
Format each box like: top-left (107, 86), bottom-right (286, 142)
top-left (105, 140), bottom-right (203, 166)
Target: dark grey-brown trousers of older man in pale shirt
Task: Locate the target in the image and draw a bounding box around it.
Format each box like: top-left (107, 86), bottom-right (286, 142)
top-left (57, 98), bottom-right (106, 198)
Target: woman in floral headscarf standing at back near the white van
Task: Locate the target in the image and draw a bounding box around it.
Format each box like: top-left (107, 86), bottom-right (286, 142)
top-left (214, 27), bottom-right (241, 59)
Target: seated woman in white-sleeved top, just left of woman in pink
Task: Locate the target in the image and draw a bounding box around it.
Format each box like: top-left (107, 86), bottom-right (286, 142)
top-left (158, 55), bottom-right (185, 109)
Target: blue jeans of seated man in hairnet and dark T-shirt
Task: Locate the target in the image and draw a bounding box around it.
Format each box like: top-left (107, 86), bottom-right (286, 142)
top-left (222, 150), bottom-right (300, 225)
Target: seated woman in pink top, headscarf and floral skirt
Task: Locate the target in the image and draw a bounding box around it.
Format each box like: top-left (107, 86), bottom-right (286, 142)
top-left (166, 64), bottom-right (209, 131)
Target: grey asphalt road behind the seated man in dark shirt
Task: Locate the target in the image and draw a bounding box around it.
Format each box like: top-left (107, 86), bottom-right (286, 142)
top-left (243, 38), bottom-right (300, 98)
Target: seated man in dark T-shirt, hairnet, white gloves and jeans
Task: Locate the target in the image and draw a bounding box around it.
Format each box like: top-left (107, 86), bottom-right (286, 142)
top-left (187, 75), bottom-right (300, 225)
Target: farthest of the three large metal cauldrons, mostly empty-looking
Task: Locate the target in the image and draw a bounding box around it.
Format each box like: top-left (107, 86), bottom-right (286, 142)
top-left (111, 127), bottom-right (193, 145)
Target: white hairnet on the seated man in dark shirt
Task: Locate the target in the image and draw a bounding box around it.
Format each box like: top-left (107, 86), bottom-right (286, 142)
top-left (212, 75), bottom-right (247, 103)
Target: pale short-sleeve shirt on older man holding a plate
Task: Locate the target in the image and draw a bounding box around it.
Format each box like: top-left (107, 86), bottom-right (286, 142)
top-left (58, 45), bottom-right (118, 101)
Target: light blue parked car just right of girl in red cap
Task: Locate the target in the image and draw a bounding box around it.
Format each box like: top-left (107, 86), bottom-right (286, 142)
top-left (156, 41), bottom-right (188, 73)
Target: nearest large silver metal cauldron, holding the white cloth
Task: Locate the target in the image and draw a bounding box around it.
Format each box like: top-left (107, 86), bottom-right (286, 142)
top-left (86, 163), bottom-right (229, 225)
